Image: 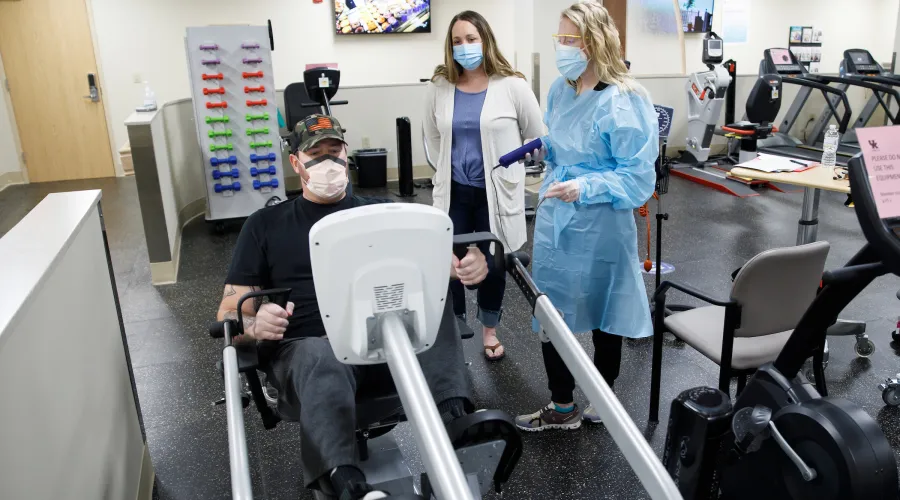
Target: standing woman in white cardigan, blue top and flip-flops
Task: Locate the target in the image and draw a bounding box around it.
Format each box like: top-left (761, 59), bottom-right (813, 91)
top-left (425, 11), bottom-right (544, 361)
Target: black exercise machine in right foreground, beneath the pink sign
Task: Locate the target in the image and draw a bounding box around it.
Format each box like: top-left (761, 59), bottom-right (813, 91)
top-left (657, 156), bottom-right (900, 500)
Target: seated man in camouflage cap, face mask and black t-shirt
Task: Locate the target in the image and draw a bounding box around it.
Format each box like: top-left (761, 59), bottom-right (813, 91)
top-left (218, 115), bottom-right (488, 500)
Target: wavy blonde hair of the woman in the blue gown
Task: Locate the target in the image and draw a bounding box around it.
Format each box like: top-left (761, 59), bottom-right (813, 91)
top-left (562, 0), bottom-right (640, 92)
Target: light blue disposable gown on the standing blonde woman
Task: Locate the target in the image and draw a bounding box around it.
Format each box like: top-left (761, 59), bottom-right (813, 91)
top-left (533, 78), bottom-right (659, 338)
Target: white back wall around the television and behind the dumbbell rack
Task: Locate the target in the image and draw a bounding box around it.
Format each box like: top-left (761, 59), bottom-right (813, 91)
top-left (88, 0), bottom-right (516, 158)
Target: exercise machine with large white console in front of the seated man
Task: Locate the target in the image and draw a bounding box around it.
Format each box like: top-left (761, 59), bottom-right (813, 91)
top-left (210, 228), bottom-right (522, 499)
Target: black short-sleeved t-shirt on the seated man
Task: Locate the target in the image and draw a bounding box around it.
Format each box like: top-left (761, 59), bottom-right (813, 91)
top-left (225, 196), bottom-right (390, 339)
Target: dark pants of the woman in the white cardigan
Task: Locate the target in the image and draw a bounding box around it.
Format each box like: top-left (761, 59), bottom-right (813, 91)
top-left (450, 182), bottom-right (506, 328)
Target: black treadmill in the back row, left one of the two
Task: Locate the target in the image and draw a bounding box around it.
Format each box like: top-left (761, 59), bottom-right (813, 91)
top-left (759, 48), bottom-right (853, 167)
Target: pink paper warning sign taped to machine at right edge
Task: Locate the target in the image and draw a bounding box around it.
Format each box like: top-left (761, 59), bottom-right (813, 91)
top-left (856, 126), bottom-right (900, 219)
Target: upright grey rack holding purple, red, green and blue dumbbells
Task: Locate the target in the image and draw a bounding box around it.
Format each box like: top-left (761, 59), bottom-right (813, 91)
top-left (185, 26), bottom-right (286, 221)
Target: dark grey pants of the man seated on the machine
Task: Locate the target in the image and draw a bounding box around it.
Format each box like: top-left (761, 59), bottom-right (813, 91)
top-left (270, 292), bottom-right (472, 487)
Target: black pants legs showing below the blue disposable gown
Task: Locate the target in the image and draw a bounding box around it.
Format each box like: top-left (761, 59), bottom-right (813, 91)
top-left (541, 330), bottom-right (622, 404)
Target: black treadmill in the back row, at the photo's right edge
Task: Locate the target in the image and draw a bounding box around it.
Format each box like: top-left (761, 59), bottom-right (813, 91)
top-left (806, 49), bottom-right (900, 146)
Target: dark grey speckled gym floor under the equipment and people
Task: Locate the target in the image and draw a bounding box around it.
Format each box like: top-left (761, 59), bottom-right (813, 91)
top-left (0, 174), bottom-right (900, 499)
